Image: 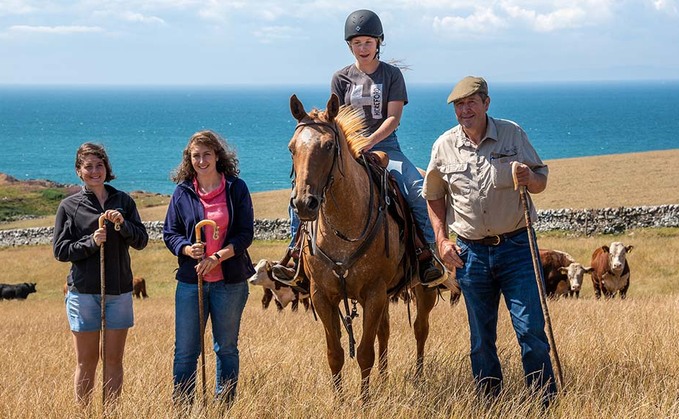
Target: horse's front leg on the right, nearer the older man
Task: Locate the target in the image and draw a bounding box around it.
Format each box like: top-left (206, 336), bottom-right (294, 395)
top-left (356, 292), bottom-right (388, 404)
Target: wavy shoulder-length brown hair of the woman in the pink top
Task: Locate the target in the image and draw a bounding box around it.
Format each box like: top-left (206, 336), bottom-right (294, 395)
top-left (171, 130), bottom-right (240, 183)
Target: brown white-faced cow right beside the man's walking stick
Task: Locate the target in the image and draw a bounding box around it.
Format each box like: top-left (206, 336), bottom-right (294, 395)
top-left (540, 249), bottom-right (592, 298)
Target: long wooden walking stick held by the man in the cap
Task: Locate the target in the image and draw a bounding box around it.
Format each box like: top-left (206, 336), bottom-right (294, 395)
top-left (512, 162), bottom-right (563, 389)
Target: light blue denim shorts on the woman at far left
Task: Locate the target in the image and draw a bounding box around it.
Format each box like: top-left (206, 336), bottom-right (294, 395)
top-left (64, 291), bottom-right (134, 332)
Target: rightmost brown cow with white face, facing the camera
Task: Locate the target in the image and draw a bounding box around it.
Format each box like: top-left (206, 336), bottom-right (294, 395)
top-left (592, 242), bottom-right (634, 299)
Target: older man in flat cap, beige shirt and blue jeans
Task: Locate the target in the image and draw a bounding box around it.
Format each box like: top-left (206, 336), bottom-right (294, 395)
top-left (423, 76), bottom-right (556, 404)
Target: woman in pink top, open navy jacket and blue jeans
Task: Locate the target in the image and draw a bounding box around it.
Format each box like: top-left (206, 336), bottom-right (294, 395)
top-left (163, 131), bottom-right (254, 405)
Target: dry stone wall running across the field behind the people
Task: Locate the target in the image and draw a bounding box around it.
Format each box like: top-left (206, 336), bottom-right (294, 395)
top-left (0, 204), bottom-right (679, 247)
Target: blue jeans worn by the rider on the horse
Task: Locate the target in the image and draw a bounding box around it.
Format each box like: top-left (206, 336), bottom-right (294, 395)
top-left (288, 133), bottom-right (436, 248)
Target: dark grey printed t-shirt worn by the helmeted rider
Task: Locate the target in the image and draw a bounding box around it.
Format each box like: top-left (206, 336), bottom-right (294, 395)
top-left (330, 61), bottom-right (408, 134)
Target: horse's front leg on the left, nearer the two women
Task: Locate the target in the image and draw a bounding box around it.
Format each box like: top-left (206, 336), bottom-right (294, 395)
top-left (311, 291), bottom-right (344, 398)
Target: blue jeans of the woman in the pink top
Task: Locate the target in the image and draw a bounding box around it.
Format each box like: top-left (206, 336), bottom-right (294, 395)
top-left (172, 281), bottom-right (249, 402)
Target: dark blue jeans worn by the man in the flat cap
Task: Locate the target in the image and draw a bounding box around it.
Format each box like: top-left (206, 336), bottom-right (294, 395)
top-left (456, 232), bottom-right (556, 399)
